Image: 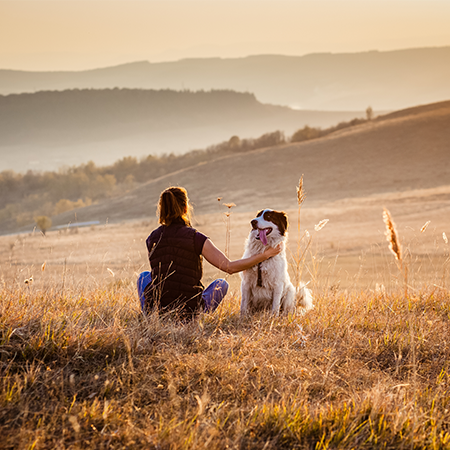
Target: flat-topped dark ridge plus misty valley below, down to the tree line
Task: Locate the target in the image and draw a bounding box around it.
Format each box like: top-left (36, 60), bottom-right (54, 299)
top-left (0, 89), bottom-right (363, 172)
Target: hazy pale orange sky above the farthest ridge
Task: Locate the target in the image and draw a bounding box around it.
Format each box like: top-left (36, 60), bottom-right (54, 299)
top-left (0, 0), bottom-right (450, 70)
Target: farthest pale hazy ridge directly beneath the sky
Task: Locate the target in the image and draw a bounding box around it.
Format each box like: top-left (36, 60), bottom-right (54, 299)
top-left (0, 47), bottom-right (450, 111)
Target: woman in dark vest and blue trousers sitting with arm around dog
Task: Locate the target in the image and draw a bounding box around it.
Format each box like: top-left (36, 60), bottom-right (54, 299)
top-left (137, 187), bottom-right (281, 318)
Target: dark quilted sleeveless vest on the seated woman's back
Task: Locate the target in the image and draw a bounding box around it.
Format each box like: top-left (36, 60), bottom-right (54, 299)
top-left (145, 222), bottom-right (203, 317)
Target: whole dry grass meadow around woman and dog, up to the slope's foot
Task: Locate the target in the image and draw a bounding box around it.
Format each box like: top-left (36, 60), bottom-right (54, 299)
top-left (0, 196), bottom-right (450, 449)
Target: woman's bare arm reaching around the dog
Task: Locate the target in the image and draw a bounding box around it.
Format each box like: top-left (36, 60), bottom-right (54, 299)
top-left (202, 239), bottom-right (281, 274)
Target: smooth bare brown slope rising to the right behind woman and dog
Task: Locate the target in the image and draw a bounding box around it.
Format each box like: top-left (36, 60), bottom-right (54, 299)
top-left (55, 101), bottom-right (450, 224)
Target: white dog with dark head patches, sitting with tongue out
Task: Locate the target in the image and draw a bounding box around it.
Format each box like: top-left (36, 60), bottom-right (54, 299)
top-left (241, 209), bottom-right (313, 316)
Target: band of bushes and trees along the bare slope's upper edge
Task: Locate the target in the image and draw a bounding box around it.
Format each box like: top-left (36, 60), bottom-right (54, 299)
top-left (0, 113), bottom-right (372, 234)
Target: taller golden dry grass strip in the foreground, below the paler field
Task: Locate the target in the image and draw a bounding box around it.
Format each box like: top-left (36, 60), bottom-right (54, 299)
top-left (0, 283), bottom-right (450, 449)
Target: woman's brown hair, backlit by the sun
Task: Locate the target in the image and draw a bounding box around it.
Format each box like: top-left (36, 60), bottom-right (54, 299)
top-left (158, 186), bottom-right (192, 226)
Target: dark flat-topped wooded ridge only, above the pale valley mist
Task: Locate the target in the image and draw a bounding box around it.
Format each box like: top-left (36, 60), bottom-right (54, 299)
top-left (0, 89), bottom-right (266, 145)
